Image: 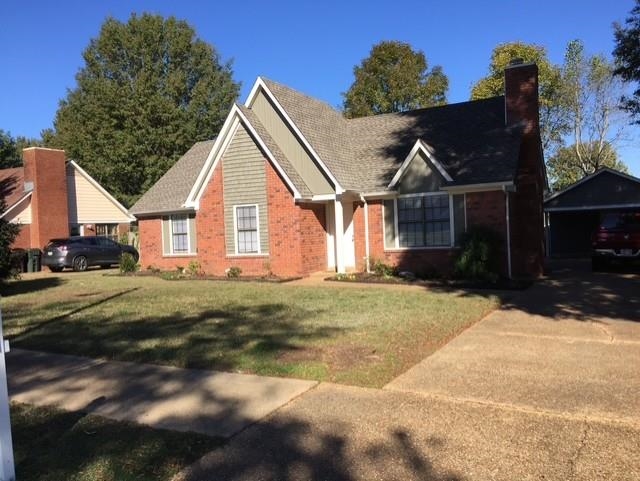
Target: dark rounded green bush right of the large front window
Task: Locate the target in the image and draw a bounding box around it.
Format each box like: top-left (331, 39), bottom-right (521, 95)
top-left (454, 226), bottom-right (502, 282)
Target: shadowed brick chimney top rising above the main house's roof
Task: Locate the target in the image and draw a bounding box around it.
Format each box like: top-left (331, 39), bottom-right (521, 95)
top-left (504, 59), bottom-right (540, 136)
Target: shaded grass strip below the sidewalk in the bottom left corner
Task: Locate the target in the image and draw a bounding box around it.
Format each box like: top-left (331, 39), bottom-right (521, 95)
top-left (11, 404), bottom-right (222, 481)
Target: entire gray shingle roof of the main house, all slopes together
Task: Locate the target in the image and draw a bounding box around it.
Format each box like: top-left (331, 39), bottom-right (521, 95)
top-left (130, 79), bottom-right (522, 215)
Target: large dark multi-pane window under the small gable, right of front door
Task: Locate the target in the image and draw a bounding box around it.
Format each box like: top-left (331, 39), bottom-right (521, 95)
top-left (397, 194), bottom-right (451, 247)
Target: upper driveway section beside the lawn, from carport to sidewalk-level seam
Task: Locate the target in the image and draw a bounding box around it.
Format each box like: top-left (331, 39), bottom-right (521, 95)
top-left (386, 264), bottom-right (640, 422)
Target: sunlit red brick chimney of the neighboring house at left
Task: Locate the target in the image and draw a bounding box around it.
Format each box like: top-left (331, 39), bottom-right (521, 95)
top-left (22, 147), bottom-right (69, 249)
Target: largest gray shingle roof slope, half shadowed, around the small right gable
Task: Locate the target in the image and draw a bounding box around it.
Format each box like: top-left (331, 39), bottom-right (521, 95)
top-left (265, 80), bottom-right (521, 192)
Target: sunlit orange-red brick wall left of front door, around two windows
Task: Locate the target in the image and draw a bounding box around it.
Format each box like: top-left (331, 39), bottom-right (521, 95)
top-left (138, 152), bottom-right (327, 277)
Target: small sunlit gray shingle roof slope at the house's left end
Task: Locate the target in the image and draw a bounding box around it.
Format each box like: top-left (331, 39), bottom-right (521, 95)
top-left (129, 140), bottom-right (215, 215)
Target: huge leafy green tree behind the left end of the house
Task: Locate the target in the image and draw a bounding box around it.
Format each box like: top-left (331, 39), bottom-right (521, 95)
top-left (50, 14), bottom-right (239, 204)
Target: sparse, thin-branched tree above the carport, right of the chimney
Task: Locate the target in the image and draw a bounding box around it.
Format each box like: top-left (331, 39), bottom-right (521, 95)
top-left (552, 40), bottom-right (626, 188)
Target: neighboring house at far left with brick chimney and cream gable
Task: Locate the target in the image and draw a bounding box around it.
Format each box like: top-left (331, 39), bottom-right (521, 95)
top-left (0, 147), bottom-right (135, 249)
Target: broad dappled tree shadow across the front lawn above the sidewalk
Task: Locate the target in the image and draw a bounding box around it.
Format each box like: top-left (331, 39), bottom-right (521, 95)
top-left (13, 300), bottom-right (343, 371)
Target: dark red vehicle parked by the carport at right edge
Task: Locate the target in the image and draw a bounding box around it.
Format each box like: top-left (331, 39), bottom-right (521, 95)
top-left (591, 212), bottom-right (640, 270)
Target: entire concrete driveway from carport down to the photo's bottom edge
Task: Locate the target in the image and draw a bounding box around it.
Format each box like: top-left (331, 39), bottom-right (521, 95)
top-left (178, 262), bottom-right (640, 481)
